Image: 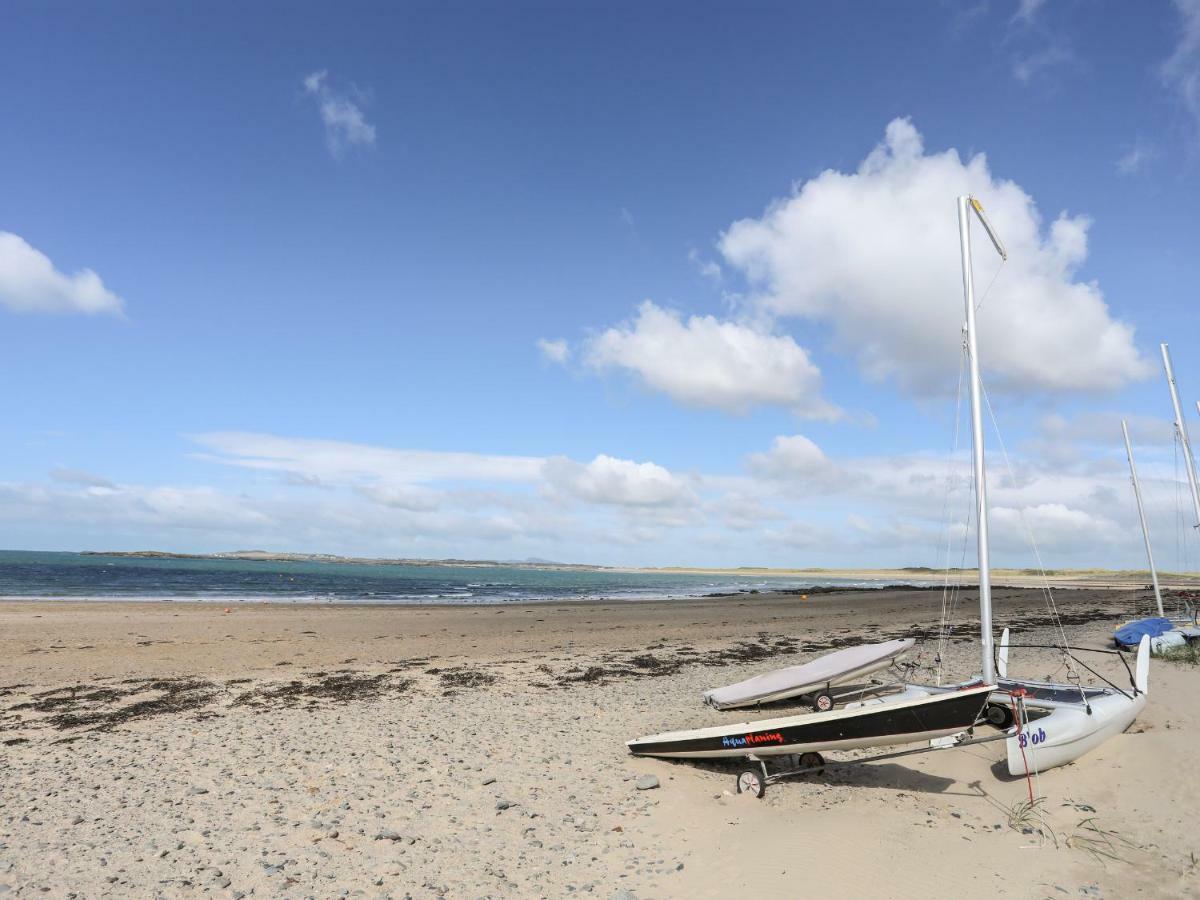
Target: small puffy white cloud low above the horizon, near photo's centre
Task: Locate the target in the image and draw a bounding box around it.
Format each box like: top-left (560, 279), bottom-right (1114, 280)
top-left (544, 454), bottom-right (696, 506)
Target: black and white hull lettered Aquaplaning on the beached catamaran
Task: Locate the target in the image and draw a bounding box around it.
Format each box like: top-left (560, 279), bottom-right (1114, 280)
top-left (626, 684), bottom-right (995, 758)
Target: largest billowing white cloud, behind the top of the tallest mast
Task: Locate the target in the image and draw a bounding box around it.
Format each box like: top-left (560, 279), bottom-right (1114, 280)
top-left (720, 119), bottom-right (1150, 394)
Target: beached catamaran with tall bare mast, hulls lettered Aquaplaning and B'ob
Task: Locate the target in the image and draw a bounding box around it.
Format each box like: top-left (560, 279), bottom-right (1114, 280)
top-left (626, 197), bottom-right (1148, 782)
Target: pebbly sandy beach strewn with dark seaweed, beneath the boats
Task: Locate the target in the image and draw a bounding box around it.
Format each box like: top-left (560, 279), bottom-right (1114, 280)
top-left (0, 589), bottom-right (1200, 900)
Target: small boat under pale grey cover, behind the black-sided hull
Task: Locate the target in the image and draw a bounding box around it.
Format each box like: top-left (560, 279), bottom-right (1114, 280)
top-left (704, 637), bottom-right (917, 709)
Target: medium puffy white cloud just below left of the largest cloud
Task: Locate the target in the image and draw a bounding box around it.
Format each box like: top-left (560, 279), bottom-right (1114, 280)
top-left (586, 300), bottom-right (838, 419)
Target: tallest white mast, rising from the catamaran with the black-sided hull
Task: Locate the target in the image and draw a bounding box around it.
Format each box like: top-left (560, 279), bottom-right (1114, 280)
top-left (959, 197), bottom-right (1008, 684)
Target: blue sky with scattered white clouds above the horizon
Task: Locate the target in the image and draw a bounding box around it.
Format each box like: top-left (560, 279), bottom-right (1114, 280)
top-left (0, 0), bottom-right (1200, 569)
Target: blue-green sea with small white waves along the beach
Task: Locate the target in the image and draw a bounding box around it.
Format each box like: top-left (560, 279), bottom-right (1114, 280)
top-left (0, 551), bottom-right (907, 604)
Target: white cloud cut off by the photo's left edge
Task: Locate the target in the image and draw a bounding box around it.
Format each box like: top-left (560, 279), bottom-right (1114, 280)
top-left (0, 232), bottom-right (125, 316)
